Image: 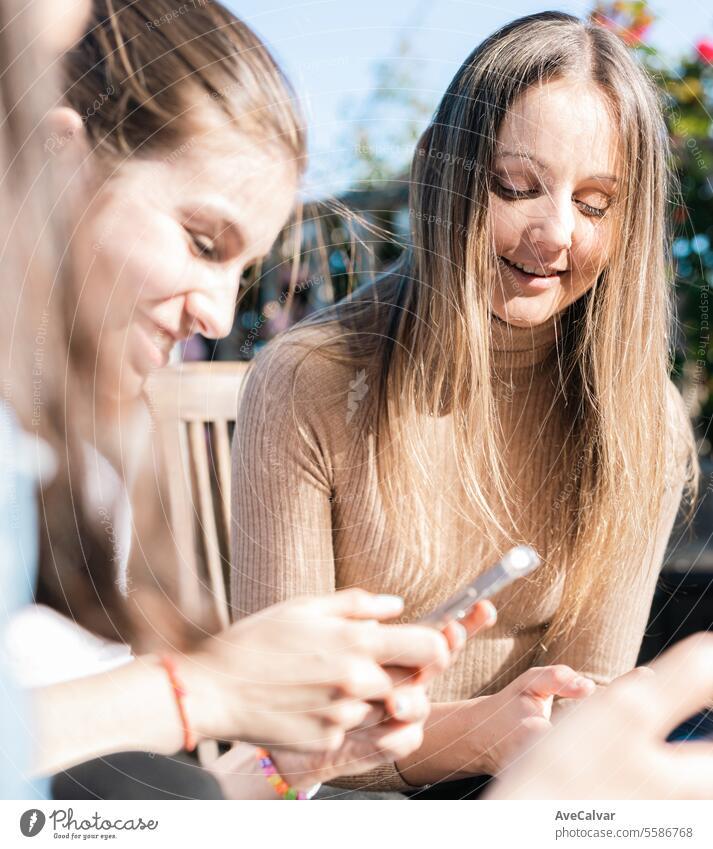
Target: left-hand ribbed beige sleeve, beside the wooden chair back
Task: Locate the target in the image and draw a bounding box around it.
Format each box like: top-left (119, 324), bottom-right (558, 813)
top-left (230, 334), bottom-right (335, 619)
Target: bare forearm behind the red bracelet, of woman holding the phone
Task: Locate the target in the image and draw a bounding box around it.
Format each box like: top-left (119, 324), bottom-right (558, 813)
top-left (32, 658), bottom-right (188, 775)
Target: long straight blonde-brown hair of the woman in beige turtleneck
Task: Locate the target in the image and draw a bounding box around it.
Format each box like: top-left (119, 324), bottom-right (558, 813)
top-left (304, 12), bottom-right (699, 637)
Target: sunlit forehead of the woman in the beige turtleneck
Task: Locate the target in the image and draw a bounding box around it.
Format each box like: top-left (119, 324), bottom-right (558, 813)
top-left (496, 79), bottom-right (619, 179)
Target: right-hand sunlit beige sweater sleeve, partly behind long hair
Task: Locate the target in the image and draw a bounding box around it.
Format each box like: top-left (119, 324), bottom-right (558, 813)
top-left (536, 383), bottom-right (692, 684)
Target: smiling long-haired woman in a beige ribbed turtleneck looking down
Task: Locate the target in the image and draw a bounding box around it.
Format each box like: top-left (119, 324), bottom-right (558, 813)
top-left (233, 12), bottom-right (698, 788)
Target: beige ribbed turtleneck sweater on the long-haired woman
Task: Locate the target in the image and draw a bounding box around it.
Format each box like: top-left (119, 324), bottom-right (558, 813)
top-left (232, 308), bottom-right (685, 789)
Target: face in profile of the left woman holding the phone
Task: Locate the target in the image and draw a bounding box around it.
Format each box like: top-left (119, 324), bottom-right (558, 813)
top-left (72, 134), bottom-right (297, 400)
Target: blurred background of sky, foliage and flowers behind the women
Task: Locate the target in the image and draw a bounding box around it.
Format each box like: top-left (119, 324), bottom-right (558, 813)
top-left (191, 0), bottom-right (713, 660)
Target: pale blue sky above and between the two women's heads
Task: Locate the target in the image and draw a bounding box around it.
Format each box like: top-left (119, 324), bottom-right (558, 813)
top-left (227, 0), bottom-right (713, 195)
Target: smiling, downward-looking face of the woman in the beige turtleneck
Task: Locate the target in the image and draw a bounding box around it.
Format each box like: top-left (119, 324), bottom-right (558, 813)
top-left (490, 80), bottom-right (621, 327)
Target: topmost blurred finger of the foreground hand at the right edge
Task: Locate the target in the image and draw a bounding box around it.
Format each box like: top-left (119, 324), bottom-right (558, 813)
top-left (607, 633), bottom-right (713, 736)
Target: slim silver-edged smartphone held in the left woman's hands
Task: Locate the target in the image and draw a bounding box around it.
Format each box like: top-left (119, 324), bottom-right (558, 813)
top-left (418, 545), bottom-right (542, 631)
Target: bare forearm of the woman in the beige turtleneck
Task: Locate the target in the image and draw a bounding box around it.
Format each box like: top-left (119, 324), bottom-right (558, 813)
top-left (396, 696), bottom-right (493, 787)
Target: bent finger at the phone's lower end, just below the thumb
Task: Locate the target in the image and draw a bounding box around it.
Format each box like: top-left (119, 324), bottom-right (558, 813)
top-left (366, 625), bottom-right (450, 671)
